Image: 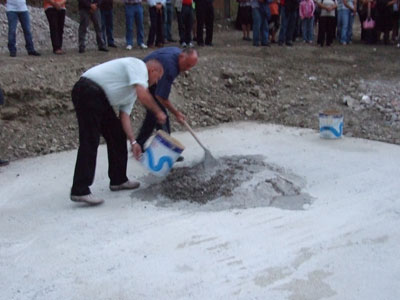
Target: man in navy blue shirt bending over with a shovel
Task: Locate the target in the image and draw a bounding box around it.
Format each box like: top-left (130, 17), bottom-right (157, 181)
top-left (133, 47), bottom-right (198, 158)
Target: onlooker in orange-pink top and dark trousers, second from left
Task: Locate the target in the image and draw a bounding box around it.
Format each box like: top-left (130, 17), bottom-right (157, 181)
top-left (43, 0), bottom-right (67, 55)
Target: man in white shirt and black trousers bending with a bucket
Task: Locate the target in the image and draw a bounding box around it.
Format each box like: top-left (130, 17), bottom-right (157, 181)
top-left (70, 57), bottom-right (166, 205)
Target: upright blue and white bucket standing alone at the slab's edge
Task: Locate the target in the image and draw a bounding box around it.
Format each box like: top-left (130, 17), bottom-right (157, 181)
top-left (319, 110), bottom-right (343, 139)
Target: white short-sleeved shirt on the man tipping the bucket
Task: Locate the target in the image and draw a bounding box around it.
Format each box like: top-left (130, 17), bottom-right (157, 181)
top-left (82, 57), bottom-right (149, 115)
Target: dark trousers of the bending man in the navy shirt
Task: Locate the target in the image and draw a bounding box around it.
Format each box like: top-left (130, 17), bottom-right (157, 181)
top-left (136, 84), bottom-right (171, 150)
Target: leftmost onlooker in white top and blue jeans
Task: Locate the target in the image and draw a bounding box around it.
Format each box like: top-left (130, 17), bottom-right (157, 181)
top-left (6, 0), bottom-right (40, 57)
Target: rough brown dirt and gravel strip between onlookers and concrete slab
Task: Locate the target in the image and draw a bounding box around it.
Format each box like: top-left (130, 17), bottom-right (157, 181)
top-left (0, 25), bottom-right (400, 160)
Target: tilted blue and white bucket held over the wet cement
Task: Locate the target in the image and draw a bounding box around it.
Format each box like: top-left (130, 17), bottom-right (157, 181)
top-left (141, 130), bottom-right (185, 177)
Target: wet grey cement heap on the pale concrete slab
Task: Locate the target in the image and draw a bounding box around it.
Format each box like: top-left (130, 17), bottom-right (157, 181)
top-left (136, 155), bottom-right (312, 210)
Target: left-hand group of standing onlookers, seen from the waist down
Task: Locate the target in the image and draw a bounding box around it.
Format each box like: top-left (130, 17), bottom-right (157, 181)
top-left (6, 0), bottom-right (214, 57)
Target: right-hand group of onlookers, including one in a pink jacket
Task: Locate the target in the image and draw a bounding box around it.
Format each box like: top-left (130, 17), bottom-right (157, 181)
top-left (237, 0), bottom-right (400, 48)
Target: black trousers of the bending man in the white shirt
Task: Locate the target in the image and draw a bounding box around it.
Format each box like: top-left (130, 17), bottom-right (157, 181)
top-left (71, 77), bottom-right (128, 196)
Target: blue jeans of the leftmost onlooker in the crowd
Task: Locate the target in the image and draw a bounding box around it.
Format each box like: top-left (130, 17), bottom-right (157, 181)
top-left (7, 11), bottom-right (35, 54)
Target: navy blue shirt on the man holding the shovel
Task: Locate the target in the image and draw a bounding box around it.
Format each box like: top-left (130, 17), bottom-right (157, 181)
top-left (143, 47), bottom-right (182, 99)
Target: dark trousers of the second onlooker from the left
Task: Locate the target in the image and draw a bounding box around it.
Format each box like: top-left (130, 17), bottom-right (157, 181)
top-left (45, 7), bottom-right (65, 52)
